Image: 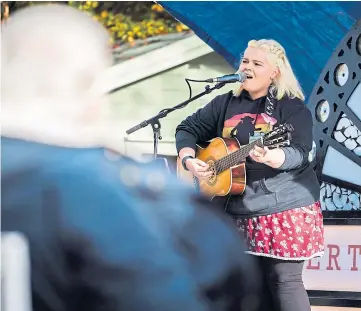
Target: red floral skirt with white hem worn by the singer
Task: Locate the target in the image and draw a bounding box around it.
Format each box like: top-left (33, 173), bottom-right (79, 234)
top-left (236, 202), bottom-right (324, 260)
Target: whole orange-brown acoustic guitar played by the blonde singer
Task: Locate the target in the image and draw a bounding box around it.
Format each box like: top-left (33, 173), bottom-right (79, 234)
top-left (177, 124), bottom-right (293, 198)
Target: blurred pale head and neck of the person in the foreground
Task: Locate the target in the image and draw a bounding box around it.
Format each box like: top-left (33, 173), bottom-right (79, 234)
top-left (1, 4), bottom-right (112, 147)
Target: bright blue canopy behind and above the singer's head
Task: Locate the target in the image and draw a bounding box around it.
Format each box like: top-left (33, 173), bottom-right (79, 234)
top-left (159, 1), bottom-right (361, 101)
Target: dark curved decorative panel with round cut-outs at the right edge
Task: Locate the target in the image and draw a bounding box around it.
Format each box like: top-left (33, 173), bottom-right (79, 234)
top-left (308, 20), bottom-right (361, 211)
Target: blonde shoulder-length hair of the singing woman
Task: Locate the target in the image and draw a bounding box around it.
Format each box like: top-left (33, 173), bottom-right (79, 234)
top-left (234, 39), bottom-right (305, 100)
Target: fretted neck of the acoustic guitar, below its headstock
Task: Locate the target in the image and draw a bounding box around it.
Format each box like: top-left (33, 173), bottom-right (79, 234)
top-left (216, 138), bottom-right (263, 174)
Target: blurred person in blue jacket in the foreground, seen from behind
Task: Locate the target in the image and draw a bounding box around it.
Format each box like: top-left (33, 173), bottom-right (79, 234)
top-left (1, 5), bottom-right (257, 311)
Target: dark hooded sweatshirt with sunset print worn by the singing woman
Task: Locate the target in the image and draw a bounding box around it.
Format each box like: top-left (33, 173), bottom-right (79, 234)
top-left (176, 91), bottom-right (320, 217)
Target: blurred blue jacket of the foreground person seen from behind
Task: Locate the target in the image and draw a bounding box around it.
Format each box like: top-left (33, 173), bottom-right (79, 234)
top-left (1, 138), bottom-right (257, 311)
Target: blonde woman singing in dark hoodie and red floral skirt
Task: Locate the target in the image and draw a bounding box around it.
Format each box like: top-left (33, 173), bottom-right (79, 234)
top-left (176, 40), bottom-right (324, 311)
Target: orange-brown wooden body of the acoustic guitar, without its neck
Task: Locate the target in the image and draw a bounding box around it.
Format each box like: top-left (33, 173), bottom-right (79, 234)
top-left (177, 137), bottom-right (246, 197)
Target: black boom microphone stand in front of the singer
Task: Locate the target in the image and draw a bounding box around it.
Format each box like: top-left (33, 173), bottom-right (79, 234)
top-left (126, 82), bottom-right (226, 160)
